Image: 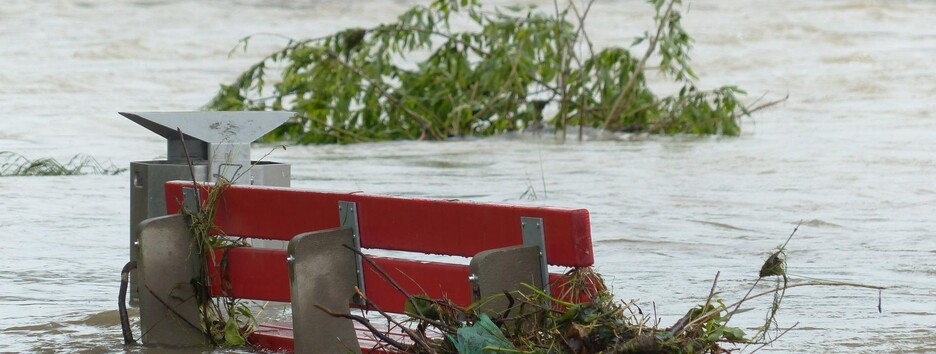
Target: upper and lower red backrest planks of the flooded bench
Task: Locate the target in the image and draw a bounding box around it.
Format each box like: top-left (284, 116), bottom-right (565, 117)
top-left (166, 181), bottom-right (594, 312)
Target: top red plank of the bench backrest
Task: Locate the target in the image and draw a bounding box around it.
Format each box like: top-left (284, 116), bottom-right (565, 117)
top-left (166, 181), bottom-right (594, 267)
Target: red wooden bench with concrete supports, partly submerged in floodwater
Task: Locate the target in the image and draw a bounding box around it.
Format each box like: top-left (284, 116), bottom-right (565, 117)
top-left (140, 182), bottom-right (594, 352)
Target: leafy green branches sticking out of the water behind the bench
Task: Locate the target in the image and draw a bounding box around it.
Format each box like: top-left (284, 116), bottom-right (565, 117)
top-left (206, 0), bottom-right (748, 143)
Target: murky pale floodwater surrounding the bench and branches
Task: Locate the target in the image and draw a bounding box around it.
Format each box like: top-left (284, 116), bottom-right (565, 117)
top-left (0, 0), bottom-right (936, 353)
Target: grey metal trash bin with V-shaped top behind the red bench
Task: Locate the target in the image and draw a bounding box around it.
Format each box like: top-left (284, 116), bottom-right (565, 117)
top-left (120, 112), bottom-right (294, 304)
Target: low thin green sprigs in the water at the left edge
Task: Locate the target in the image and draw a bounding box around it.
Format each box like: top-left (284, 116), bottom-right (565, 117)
top-left (0, 151), bottom-right (127, 177)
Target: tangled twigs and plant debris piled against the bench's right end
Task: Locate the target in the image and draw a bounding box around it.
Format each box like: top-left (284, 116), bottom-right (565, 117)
top-left (334, 226), bottom-right (884, 354)
